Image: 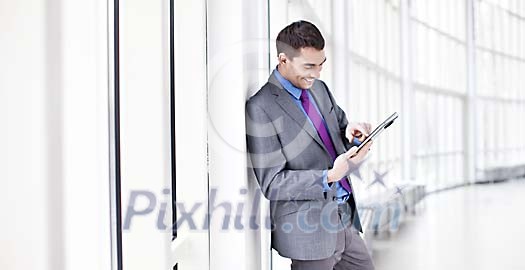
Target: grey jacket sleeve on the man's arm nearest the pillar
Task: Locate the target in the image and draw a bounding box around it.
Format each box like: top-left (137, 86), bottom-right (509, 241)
top-left (246, 100), bottom-right (326, 201)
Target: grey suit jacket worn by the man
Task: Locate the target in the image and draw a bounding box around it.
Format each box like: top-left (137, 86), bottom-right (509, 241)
top-left (246, 71), bottom-right (361, 260)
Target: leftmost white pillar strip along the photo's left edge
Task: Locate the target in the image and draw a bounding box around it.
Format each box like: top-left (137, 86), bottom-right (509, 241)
top-left (0, 1), bottom-right (50, 270)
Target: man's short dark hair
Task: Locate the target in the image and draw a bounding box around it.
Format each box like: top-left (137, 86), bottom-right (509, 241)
top-left (276, 21), bottom-right (324, 58)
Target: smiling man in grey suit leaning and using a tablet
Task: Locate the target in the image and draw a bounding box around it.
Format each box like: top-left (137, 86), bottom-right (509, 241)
top-left (246, 21), bottom-right (374, 270)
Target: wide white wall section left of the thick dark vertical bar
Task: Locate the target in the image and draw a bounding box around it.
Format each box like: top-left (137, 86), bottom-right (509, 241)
top-left (0, 0), bottom-right (111, 270)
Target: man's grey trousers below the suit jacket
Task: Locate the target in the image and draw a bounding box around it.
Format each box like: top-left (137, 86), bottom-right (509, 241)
top-left (291, 204), bottom-right (375, 270)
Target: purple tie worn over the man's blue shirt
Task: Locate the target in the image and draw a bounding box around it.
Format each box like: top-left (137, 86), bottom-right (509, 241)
top-left (301, 90), bottom-right (352, 193)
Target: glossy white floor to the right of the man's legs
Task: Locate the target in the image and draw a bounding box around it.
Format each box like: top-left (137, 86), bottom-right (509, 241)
top-left (373, 179), bottom-right (525, 270)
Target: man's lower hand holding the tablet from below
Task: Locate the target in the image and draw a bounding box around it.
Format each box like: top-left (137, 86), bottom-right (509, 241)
top-left (327, 141), bottom-right (372, 183)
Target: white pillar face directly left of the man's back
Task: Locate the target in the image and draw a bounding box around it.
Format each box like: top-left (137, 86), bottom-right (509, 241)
top-left (206, 0), bottom-right (248, 269)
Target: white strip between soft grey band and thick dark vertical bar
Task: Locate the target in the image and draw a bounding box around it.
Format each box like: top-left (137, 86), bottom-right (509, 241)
top-left (61, 0), bottom-right (111, 269)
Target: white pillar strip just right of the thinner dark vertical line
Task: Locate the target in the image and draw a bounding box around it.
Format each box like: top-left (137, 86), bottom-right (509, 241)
top-left (170, 0), bottom-right (210, 270)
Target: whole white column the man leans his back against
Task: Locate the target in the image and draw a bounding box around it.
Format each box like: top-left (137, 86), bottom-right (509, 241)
top-left (207, 0), bottom-right (268, 270)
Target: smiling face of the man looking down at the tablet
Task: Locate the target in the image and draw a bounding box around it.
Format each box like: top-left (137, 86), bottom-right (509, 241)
top-left (279, 47), bottom-right (326, 89)
